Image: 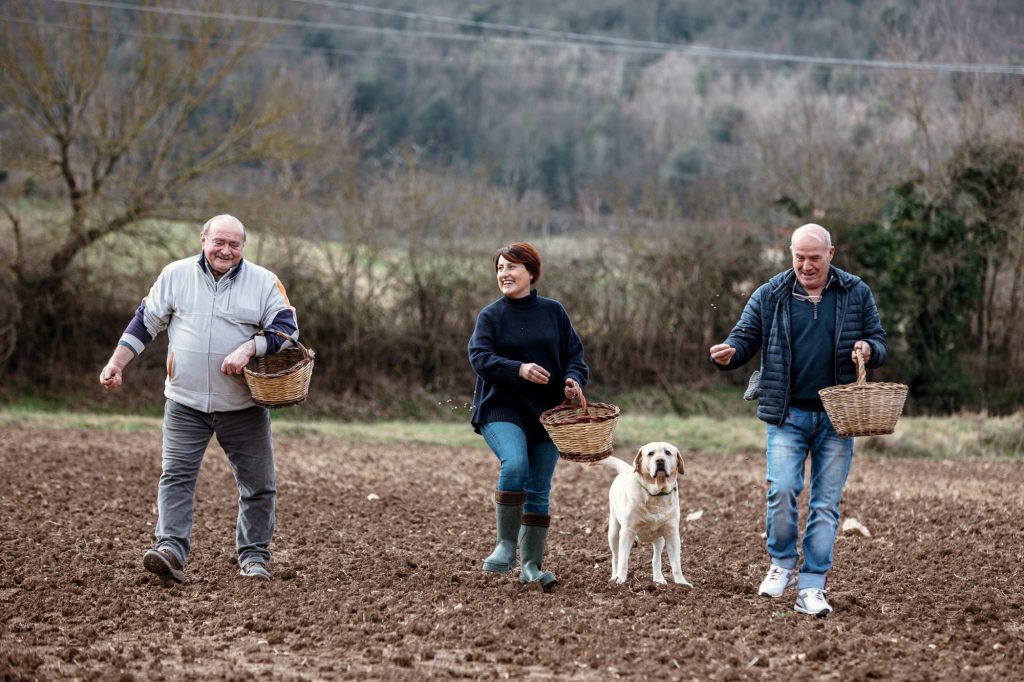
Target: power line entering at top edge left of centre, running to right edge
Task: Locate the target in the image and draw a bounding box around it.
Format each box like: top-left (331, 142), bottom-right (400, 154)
top-left (291, 0), bottom-right (1024, 75)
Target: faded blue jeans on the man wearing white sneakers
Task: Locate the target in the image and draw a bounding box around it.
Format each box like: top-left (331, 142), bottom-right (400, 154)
top-left (765, 408), bottom-right (853, 590)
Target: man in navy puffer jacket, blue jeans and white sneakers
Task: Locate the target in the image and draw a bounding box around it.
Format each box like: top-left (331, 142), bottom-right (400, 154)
top-left (711, 224), bottom-right (888, 616)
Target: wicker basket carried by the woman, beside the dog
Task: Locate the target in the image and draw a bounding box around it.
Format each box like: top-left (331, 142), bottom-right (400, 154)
top-left (541, 389), bottom-right (618, 462)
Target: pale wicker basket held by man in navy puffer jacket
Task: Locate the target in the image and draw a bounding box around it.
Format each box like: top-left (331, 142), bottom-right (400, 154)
top-left (818, 353), bottom-right (906, 436)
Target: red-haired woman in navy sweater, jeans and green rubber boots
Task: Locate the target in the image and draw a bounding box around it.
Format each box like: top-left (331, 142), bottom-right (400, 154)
top-left (469, 242), bottom-right (589, 590)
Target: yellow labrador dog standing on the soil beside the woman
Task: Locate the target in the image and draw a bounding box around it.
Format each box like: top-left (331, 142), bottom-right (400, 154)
top-left (601, 442), bottom-right (693, 587)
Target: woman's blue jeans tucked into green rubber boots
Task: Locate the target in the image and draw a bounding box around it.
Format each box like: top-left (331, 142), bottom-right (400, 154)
top-left (480, 422), bottom-right (558, 514)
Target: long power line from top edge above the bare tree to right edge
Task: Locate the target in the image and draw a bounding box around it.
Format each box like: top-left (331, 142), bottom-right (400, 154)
top-left (44, 0), bottom-right (1024, 76)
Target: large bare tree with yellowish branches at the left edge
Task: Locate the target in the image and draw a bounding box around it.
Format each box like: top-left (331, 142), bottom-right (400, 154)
top-left (0, 3), bottom-right (307, 364)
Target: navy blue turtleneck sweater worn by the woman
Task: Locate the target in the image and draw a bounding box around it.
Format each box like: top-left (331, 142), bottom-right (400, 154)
top-left (469, 289), bottom-right (590, 441)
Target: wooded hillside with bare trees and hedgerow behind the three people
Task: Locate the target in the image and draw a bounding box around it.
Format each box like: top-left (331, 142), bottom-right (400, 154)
top-left (0, 0), bottom-right (1024, 412)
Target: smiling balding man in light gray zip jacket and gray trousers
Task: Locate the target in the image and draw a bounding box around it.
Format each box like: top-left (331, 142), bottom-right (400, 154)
top-left (99, 215), bottom-right (299, 583)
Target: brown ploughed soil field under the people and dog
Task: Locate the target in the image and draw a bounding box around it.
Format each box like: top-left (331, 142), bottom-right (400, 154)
top-left (0, 429), bottom-right (1024, 680)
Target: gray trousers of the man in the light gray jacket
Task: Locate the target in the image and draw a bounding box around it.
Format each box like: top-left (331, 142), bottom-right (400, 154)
top-left (157, 399), bottom-right (278, 566)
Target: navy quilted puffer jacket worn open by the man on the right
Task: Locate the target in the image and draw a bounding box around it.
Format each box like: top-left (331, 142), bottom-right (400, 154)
top-left (712, 265), bottom-right (889, 425)
